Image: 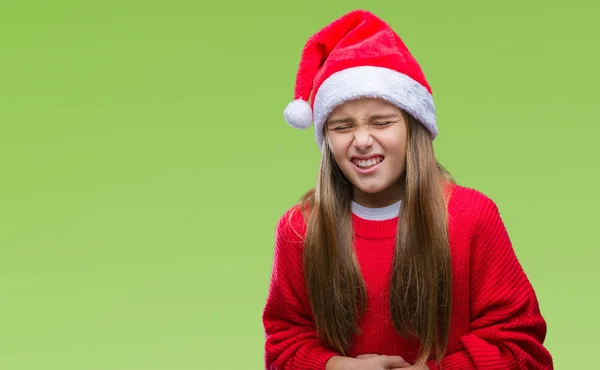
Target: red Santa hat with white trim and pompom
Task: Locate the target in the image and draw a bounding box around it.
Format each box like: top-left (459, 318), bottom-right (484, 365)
top-left (284, 10), bottom-right (437, 150)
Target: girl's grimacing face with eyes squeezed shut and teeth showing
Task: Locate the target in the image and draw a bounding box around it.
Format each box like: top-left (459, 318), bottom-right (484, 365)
top-left (324, 98), bottom-right (407, 207)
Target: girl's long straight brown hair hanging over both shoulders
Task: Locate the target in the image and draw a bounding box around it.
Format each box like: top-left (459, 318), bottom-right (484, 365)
top-left (301, 114), bottom-right (454, 364)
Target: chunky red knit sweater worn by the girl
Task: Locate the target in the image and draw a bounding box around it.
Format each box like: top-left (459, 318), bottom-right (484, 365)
top-left (263, 185), bottom-right (553, 370)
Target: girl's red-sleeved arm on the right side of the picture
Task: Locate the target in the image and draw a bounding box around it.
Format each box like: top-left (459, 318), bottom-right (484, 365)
top-left (428, 197), bottom-right (553, 370)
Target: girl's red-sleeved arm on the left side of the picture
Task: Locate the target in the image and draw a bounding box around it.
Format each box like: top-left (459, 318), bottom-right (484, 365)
top-left (263, 209), bottom-right (339, 370)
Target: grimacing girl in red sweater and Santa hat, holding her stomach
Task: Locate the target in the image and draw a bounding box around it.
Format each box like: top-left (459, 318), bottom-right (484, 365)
top-left (263, 11), bottom-right (553, 370)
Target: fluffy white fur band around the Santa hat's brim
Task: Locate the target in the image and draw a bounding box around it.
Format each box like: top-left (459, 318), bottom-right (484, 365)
top-left (314, 66), bottom-right (438, 150)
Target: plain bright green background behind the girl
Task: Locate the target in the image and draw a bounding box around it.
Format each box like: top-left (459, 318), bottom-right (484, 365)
top-left (0, 0), bottom-right (600, 370)
